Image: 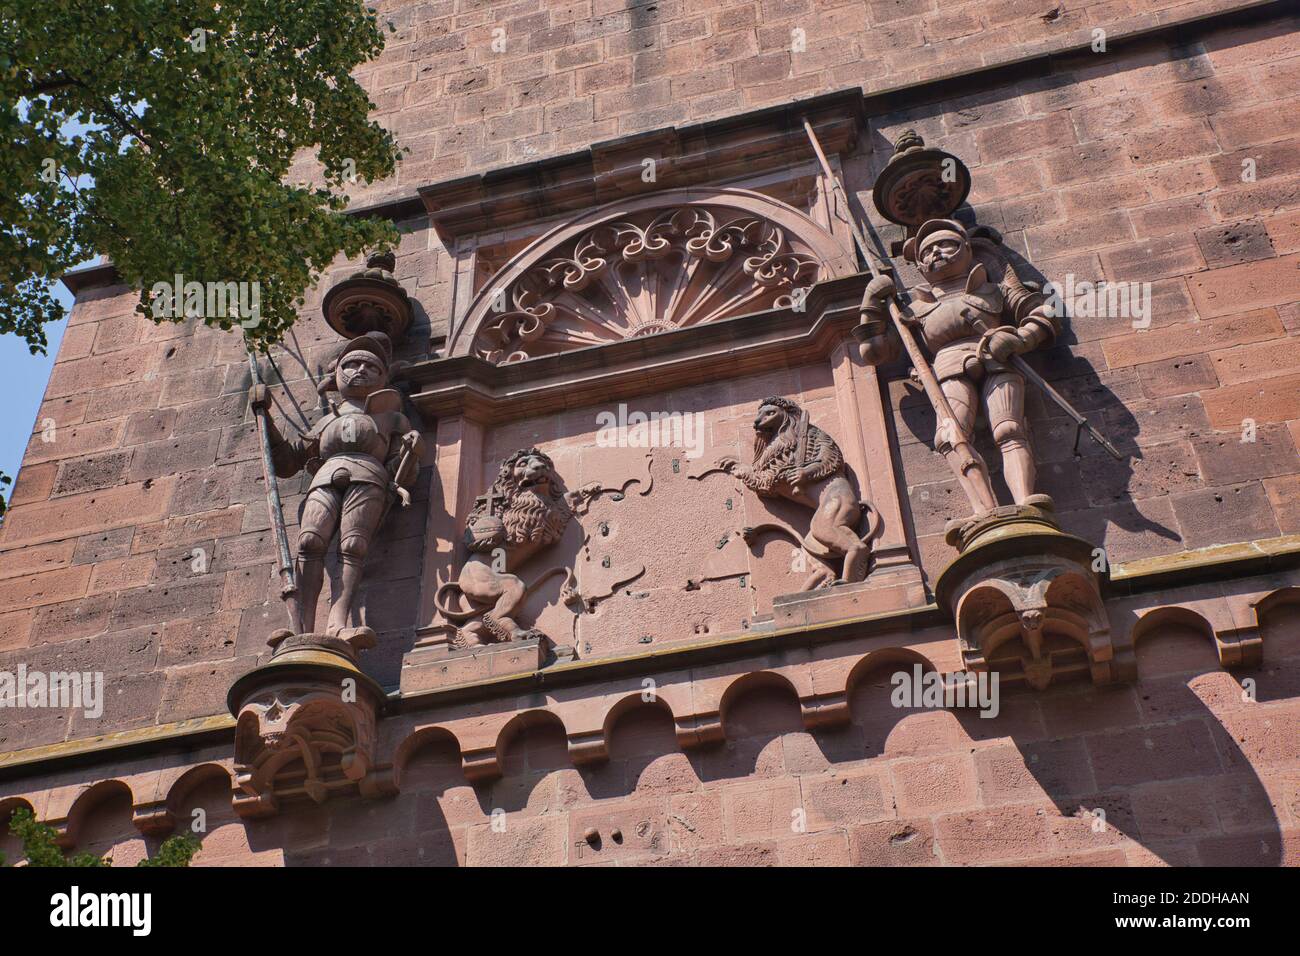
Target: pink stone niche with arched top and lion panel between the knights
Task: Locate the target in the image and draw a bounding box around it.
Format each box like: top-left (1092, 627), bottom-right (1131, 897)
top-left (402, 106), bottom-right (927, 693)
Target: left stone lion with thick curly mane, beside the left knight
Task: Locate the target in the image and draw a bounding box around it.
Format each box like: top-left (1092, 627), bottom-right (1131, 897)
top-left (434, 447), bottom-right (598, 648)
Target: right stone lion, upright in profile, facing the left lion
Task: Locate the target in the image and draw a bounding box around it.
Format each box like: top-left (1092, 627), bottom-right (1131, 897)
top-left (718, 398), bottom-right (880, 591)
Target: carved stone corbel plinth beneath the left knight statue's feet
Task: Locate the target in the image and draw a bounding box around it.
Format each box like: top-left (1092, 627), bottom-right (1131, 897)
top-left (226, 633), bottom-right (395, 817)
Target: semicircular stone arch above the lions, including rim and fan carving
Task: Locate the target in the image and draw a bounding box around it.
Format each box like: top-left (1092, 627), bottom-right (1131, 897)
top-left (447, 189), bottom-right (857, 364)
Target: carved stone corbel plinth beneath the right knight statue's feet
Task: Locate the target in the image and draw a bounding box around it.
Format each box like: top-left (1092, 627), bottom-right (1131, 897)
top-left (935, 505), bottom-right (1136, 689)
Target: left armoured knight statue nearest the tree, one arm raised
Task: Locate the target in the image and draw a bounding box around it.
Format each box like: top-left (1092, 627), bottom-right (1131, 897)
top-left (248, 332), bottom-right (424, 646)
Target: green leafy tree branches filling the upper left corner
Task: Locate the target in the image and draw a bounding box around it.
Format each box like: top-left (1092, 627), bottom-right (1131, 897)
top-left (0, 0), bottom-right (399, 354)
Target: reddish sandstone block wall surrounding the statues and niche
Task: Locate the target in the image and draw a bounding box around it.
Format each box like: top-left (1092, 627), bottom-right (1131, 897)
top-left (0, 0), bottom-right (1300, 864)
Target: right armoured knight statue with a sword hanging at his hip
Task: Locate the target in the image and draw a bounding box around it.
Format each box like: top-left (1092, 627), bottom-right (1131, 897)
top-left (858, 219), bottom-right (1061, 509)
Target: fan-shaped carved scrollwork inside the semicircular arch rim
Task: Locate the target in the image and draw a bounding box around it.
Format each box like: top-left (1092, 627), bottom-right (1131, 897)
top-left (475, 206), bottom-right (822, 363)
